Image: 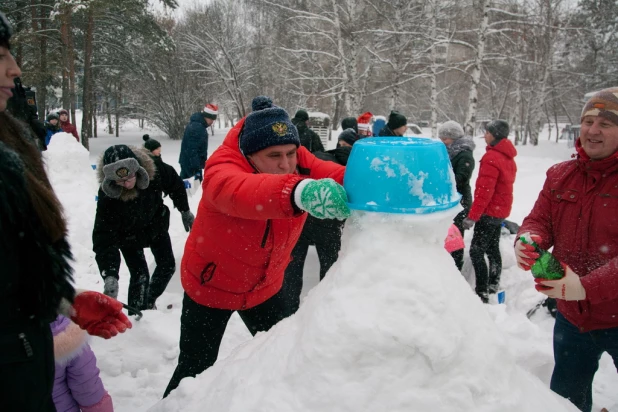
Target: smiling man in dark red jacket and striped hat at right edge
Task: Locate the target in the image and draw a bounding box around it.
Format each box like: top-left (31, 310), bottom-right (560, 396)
top-left (515, 87), bottom-right (618, 411)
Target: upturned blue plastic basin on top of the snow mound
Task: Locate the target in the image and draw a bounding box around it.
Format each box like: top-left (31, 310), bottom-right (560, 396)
top-left (343, 137), bottom-right (461, 214)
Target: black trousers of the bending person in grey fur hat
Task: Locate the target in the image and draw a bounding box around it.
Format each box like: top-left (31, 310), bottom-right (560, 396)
top-left (120, 232), bottom-right (176, 309)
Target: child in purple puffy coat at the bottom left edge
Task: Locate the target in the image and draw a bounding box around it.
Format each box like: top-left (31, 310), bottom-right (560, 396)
top-left (51, 315), bottom-right (114, 412)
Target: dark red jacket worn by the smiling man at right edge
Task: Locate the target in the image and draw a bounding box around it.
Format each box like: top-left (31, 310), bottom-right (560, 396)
top-left (518, 140), bottom-right (618, 332)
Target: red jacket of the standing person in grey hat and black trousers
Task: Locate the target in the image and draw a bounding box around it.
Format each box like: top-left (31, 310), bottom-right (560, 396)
top-left (468, 139), bottom-right (517, 222)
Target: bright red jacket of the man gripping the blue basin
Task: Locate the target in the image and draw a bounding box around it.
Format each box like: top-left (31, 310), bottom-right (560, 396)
top-left (181, 119), bottom-right (345, 310)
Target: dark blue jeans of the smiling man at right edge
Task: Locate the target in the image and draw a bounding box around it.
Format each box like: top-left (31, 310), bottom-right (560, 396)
top-left (550, 312), bottom-right (618, 412)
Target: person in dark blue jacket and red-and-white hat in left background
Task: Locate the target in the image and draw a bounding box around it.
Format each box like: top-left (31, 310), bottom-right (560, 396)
top-left (178, 103), bottom-right (218, 182)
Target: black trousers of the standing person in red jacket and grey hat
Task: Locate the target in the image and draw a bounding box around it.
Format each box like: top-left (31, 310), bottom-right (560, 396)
top-left (470, 215), bottom-right (502, 302)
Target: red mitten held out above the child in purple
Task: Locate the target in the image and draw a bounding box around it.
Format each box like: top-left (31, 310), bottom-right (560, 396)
top-left (71, 291), bottom-right (132, 339)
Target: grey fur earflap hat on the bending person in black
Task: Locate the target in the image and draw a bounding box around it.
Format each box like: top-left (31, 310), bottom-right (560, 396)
top-left (101, 144), bottom-right (150, 199)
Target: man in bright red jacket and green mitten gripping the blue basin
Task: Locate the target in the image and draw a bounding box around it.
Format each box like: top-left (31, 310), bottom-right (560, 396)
top-left (163, 96), bottom-right (350, 397)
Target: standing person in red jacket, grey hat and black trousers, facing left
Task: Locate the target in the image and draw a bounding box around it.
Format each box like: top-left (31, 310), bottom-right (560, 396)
top-left (462, 120), bottom-right (517, 303)
